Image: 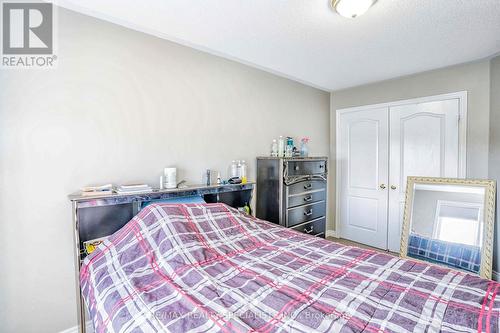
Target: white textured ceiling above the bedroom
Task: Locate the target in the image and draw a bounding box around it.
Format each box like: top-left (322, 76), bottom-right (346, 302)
top-left (56, 0), bottom-right (500, 90)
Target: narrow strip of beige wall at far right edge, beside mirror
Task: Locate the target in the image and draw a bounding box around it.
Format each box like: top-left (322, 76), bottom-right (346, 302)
top-left (488, 56), bottom-right (500, 272)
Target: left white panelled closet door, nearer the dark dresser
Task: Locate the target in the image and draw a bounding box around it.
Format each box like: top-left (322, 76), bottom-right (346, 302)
top-left (337, 108), bottom-right (389, 249)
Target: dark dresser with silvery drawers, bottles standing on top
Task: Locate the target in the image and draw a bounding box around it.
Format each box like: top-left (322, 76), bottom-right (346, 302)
top-left (256, 157), bottom-right (328, 238)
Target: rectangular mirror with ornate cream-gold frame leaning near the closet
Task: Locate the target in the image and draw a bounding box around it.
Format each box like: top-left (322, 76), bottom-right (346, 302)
top-left (400, 177), bottom-right (495, 279)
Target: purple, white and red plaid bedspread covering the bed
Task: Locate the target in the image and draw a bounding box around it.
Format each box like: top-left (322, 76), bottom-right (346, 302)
top-left (81, 204), bottom-right (500, 333)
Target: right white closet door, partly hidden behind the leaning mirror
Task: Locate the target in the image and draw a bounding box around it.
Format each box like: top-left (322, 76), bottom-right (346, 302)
top-left (388, 99), bottom-right (460, 252)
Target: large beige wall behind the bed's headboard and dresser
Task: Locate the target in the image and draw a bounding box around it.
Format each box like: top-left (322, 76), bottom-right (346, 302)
top-left (0, 10), bottom-right (330, 333)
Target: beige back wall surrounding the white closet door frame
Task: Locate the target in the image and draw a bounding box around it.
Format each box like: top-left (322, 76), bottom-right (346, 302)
top-left (328, 61), bottom-right (490, 229)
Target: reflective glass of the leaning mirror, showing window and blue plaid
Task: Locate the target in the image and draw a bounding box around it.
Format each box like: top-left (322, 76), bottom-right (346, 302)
top-left (407, 183), bottom-right (485, 274)
